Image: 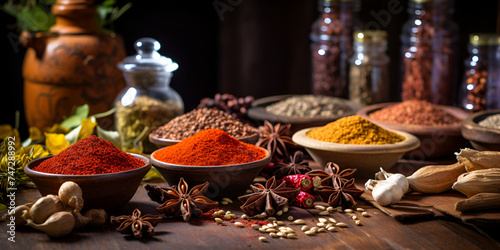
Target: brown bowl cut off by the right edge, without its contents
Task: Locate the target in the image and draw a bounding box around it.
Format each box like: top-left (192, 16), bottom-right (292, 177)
top-left (462, 109), bottom-right (500, 151)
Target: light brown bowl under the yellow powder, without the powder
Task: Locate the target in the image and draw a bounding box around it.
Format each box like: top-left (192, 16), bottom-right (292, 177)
top-left (292, 128), bottom-right (420, 178)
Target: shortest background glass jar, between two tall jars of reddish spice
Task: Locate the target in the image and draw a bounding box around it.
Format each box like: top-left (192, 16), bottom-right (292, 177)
top-left (349, 30), bottom-right (389, 105)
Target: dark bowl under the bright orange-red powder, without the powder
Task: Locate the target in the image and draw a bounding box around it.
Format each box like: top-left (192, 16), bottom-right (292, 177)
top-left (151, 149), bottom-right (271, 199)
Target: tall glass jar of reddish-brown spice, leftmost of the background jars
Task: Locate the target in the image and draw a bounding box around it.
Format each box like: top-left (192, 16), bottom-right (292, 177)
top-left (310, 0), bottom-right (360, 98)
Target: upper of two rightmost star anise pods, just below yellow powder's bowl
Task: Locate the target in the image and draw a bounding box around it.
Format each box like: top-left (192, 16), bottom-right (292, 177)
top-left (306, 162), bottom-right (356, 186)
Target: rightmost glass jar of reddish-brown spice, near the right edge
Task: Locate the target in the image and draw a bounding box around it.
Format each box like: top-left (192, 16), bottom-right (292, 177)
top-left (459, 33), bottom-right (498, 111)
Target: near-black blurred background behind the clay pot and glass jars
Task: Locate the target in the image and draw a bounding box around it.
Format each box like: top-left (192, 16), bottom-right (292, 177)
top-left (0, 0), bottom-right (498, 139)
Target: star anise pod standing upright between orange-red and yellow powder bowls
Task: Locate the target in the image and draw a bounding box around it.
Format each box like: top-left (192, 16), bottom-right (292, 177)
top-left (255, 120), bottom-right (295, 158)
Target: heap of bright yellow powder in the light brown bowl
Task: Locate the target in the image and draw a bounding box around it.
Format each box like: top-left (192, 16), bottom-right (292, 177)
top-left (306, 115), bottom-right (405, 145)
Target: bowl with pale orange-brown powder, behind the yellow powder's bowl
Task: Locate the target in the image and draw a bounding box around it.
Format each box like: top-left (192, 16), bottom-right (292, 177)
top-left (357, 100), bottom-right (469, 159)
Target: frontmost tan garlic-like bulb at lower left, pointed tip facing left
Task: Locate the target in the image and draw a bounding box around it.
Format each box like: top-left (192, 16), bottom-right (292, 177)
top-left (26, 211), bottom-right (75, 237)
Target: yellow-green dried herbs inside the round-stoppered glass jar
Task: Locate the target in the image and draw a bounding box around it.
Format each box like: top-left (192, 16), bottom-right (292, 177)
top-left (116, 96), bottom-right (183, 148)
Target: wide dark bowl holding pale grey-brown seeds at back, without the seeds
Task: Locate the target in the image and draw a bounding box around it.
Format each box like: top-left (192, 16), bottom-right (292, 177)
top-left (248, 95), bottom-right (361, 133)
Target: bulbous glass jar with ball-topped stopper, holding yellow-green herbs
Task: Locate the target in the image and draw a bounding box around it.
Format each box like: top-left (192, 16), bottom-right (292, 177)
top-left (115, 38), bottom-right (184, 153)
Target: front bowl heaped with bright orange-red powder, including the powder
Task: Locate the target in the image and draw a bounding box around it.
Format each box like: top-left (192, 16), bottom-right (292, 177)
top-left (151, 129), bottom-right (271, 199)
